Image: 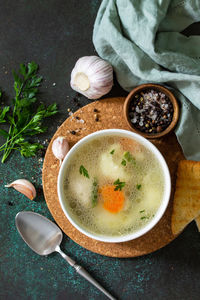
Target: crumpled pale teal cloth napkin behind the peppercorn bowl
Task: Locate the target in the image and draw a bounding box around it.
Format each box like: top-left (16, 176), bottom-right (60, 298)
top-left (93, 0), bottom-right (200, 160)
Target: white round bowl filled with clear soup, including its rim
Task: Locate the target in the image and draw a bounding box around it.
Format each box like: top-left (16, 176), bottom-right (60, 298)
top-left (57, 129), bottom-right (171, 243)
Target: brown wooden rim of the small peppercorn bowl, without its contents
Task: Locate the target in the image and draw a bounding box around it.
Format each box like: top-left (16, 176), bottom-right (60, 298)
top-left (123, 83), bottom-right (179, 139)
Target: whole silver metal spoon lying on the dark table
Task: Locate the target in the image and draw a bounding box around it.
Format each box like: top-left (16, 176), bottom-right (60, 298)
top-left (15, 211), bottom-right (116, 300)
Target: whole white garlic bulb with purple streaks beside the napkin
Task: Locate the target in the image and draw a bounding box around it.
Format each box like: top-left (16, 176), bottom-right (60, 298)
top-left (70, 56), bottom-right (113, 99)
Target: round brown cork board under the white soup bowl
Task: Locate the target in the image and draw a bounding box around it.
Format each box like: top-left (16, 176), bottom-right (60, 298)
top-left (42, 98), bottom-right (184, 257)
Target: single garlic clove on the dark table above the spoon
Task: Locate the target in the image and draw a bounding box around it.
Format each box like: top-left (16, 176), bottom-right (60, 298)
top-left (5, 179), bottom-right (36, 200)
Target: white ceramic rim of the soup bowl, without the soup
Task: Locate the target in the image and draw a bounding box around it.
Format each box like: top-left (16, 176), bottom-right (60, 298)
top-left (57, 129), bottom-right (171, 243)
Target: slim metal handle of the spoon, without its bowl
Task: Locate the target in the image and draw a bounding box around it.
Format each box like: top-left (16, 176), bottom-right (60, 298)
top-left (55, 246), bottom-right (116, 300)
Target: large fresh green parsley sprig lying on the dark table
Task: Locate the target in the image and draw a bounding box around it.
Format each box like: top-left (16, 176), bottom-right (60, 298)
top-left (0, 62), bottom-right (58, 163)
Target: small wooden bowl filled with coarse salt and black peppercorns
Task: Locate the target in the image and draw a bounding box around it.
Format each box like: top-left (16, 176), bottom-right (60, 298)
top-left (124, 84), bottom-right (179, 138)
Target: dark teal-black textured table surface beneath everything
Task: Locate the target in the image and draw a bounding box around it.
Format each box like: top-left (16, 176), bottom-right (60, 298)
top-left (0, 0), bottom-right (200, 300)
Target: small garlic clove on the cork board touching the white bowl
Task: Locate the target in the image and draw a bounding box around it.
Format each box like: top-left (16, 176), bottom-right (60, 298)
top-left (52, 136), bottom-right (69, 165)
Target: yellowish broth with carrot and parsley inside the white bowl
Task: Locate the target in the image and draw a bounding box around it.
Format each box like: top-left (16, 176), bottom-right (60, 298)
top-left (64, 136), bottom-right (164, 236)
